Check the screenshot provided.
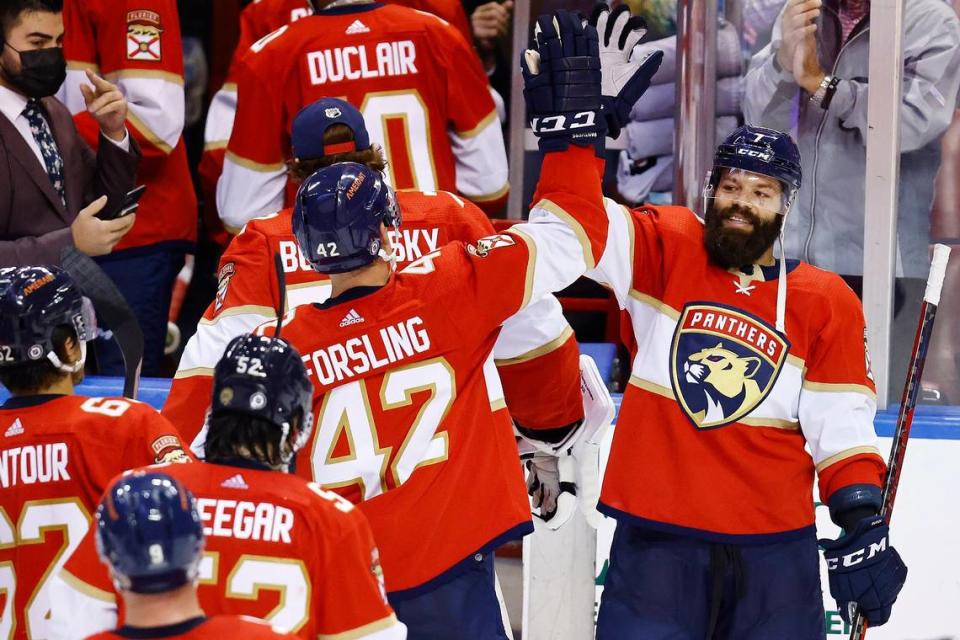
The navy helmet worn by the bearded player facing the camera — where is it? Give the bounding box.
[704,125,802,214]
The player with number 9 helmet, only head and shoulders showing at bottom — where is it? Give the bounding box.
[84,471,289,640]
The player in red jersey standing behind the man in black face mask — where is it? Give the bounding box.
[62,0,197,376]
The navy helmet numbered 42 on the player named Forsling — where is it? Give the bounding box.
[293,162,400,273]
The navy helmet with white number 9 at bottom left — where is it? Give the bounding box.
[95,471,203,593]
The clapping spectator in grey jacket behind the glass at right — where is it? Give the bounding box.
[744,0,960,278]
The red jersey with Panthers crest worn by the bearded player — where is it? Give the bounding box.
[568,195,885,542]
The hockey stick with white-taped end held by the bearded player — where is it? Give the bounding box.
[850,244,950,640]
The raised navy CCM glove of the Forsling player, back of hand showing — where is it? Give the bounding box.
[520,10,606,156]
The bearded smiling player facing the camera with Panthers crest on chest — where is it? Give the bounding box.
[556,5,906,640]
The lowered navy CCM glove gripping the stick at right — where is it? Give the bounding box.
[819,515,907,627]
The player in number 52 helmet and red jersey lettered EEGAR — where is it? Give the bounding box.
[54,334,406,640]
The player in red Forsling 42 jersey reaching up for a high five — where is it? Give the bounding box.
[249,19,659,640]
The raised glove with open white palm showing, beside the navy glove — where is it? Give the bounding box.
[590,2,663,138]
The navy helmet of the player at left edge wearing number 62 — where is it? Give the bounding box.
[0,267,96,372]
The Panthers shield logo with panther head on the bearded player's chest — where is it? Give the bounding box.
[670,302,790,429]
